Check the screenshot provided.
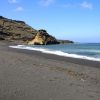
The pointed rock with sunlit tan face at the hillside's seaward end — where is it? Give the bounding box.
[28,30,59,45]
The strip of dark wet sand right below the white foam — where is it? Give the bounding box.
[8,43,100,68]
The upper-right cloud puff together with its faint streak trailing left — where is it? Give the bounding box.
[63,1,93,9]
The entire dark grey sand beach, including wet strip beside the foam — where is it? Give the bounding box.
[0,42,100,100]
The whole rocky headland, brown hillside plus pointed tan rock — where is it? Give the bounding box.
[0,16,73,45]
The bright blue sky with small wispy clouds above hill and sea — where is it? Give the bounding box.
[0,0,100,43]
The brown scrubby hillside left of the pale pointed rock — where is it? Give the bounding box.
[0,16,37,41]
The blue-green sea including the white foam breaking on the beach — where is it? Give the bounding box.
[10,43,100,61]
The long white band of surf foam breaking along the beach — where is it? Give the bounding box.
[9,45,100,61]
